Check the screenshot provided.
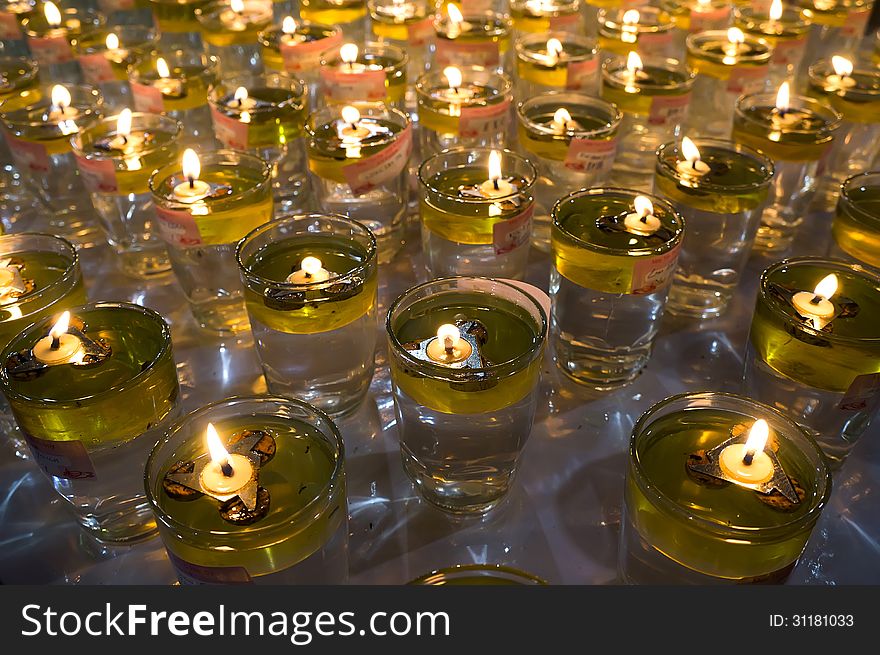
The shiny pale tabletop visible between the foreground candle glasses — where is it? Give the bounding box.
[0,208,880,584]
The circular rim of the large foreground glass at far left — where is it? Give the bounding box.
[0,300,177,406]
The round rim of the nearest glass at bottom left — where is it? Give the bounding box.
[144,395,345,538]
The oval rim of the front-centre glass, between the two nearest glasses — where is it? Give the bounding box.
[385,275,549,381]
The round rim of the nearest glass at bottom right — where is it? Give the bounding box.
[627,391,832,539]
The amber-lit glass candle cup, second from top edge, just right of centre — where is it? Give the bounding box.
[516,32,599,99]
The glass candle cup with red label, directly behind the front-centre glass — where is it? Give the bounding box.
[419,148,537,279]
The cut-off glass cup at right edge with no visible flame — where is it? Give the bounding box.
[831,171,880,269]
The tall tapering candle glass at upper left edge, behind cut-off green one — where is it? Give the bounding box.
[0,86,103,247]
